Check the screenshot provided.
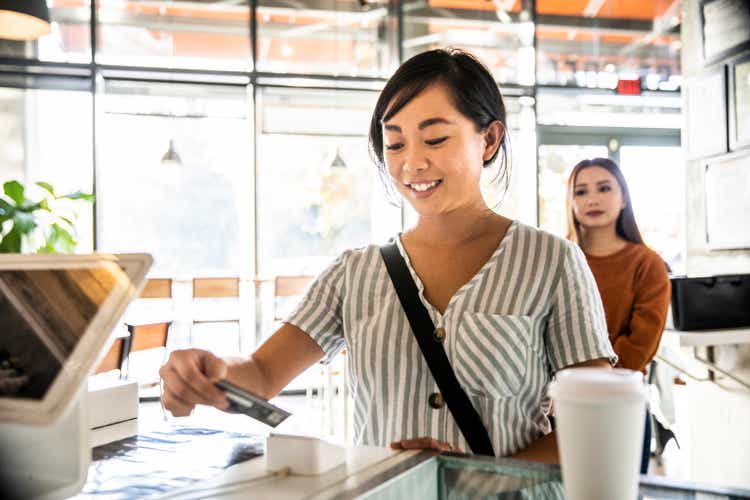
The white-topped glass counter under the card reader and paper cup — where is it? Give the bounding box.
[76,418,750,500]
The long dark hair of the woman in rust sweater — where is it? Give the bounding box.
[565,158,643,245]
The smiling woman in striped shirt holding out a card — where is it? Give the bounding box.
[161,50,615,462]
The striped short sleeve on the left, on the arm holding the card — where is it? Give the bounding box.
[284,253,347,364]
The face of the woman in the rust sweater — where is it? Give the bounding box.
[573,166,625,228]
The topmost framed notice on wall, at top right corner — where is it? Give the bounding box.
[701,0,750,63]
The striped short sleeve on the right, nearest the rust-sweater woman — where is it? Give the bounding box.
[545,241,617,373]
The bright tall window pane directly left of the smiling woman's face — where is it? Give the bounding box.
[258,89,400,276]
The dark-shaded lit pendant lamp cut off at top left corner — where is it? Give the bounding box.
[0,0,51,41]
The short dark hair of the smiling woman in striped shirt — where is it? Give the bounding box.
[370,48,510,203]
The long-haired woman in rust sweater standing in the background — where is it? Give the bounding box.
[567,158,670,473]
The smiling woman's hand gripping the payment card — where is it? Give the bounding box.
[159,349,234,417]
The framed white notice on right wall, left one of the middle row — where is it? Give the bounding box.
[685,66,727,158]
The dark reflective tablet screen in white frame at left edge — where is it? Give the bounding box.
[0,265,119,400]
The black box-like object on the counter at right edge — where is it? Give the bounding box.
[670,274,750,330]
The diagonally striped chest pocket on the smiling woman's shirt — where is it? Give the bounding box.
[454,312,538,399]
